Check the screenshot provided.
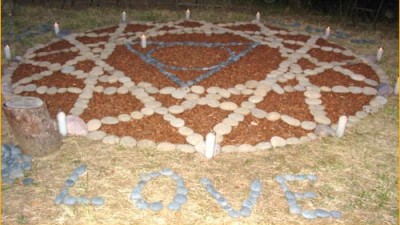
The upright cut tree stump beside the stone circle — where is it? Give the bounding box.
[3,96,62,156]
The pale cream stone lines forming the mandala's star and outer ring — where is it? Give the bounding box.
[2,20,388,154]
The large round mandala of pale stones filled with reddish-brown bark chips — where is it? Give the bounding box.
[3,21,387,153]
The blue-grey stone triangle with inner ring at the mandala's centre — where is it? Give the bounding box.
[125,41,259,87]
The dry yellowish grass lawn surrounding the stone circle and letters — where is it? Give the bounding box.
[2,3,399,224]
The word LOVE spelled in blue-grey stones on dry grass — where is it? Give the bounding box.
[55,165,342,219]
